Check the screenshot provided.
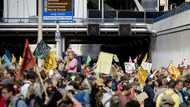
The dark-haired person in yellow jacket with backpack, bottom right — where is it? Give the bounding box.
[156,81,180,107]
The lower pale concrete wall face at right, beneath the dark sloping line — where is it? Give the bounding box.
[151,30,190,68]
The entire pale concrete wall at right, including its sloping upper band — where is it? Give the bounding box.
[151,10,190,68]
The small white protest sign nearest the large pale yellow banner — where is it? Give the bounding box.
[124,62,135,73]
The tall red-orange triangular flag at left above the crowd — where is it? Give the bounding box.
[21,39,36,72]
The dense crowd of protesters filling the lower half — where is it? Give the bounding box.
[0,50,190,107]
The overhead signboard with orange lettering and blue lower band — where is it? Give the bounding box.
[43,0,73,21]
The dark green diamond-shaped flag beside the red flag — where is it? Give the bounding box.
[34,40,50,59]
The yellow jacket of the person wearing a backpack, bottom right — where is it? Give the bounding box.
[156,89,180,107]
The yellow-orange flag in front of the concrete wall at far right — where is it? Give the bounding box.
[168,64,180,80]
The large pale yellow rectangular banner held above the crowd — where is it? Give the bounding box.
[95,52,113,74]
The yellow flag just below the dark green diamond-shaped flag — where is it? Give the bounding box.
[44,51,57,72]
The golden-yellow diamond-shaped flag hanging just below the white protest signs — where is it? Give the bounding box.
[137,67,148,87]
